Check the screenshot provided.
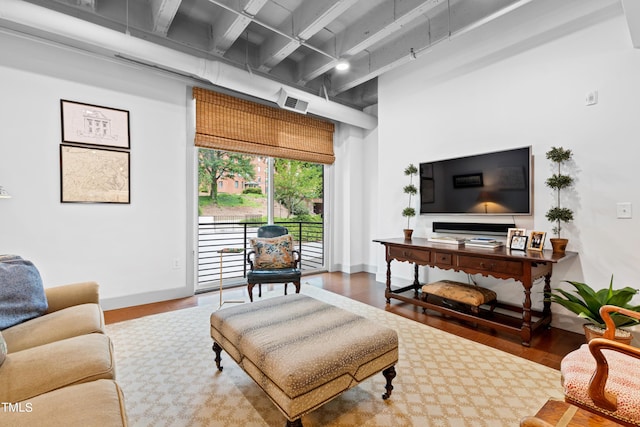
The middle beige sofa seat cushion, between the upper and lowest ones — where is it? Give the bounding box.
[0,334,115,402]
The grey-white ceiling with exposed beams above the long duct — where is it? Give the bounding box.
[13,0,531,109]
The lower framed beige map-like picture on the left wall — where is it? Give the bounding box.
[60,144,131,204]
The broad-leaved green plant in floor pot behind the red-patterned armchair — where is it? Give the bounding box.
[548,276,640,344]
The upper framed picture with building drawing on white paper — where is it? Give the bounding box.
[60,99,131,149]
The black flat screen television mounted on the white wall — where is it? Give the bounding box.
[420,147,532,215]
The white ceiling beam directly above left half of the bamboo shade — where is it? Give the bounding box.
[211,0,267,55]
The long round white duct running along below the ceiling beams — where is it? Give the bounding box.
[0,0,378,129]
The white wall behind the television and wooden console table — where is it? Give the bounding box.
[372,0,640,330]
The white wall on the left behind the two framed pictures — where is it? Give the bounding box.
[0,33,193,308]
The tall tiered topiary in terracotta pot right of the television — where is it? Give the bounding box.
[546,147,573,253]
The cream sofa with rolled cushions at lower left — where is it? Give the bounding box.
[0,282,127,426]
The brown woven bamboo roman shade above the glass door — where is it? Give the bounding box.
[193,87,335,164]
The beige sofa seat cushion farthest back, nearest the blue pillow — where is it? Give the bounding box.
[3,304,104,353]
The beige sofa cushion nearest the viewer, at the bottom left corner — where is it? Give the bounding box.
[2,380,127,427]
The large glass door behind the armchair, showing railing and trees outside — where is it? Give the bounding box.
[198,148,324,289]
